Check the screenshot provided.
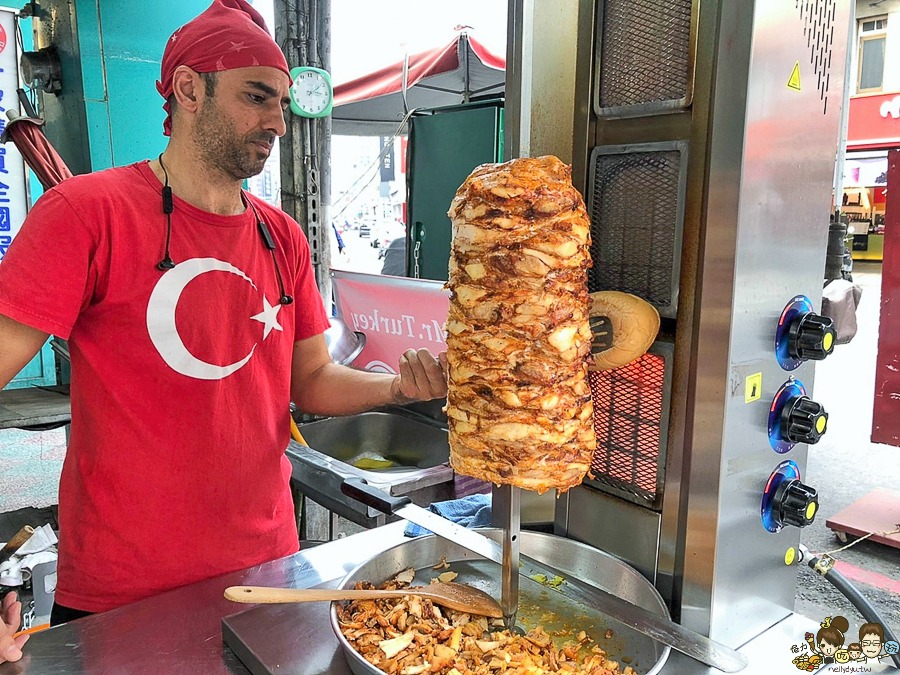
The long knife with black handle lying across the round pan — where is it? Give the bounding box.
[341,478,748,673]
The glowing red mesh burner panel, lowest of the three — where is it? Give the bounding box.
[588,354,666,505]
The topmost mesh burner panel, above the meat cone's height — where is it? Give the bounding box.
[599,0,691,108]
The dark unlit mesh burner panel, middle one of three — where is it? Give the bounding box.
[588,150,681,310]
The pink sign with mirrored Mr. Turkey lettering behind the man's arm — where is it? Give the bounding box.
[331,270,450,373]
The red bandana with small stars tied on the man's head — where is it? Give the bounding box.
[156,0,291,136]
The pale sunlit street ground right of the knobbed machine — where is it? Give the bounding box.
[796,263,900,633]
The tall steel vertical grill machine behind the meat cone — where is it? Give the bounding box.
[556,0,850,647]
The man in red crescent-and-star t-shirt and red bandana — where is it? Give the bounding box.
[0,0,446,662]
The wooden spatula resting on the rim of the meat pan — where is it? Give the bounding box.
[225,583,503,619]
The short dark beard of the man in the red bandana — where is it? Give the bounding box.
[194,100,275,180]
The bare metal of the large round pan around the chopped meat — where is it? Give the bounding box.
[331,529,669,675]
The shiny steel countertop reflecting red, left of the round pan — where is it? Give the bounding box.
[0,521,406,675]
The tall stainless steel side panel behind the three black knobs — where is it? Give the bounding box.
[681,0,848,646]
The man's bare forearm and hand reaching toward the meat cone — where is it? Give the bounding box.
[291,335,447,415]
